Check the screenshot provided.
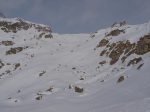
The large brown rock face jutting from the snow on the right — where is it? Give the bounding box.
[97,24,150,66]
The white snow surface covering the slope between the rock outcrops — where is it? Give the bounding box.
[0,19,150,112]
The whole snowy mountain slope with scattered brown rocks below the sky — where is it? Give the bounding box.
[0,18,150,112]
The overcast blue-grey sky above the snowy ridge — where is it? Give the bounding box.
[0,0,150,33]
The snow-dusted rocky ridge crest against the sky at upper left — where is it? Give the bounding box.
[0,18,53,39]
